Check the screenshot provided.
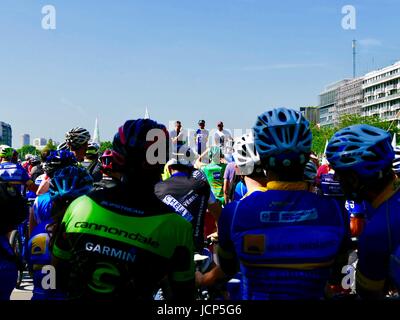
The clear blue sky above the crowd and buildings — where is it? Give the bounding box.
[0,0,400,147]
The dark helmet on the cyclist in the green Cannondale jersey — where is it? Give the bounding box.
[113,119,170,170]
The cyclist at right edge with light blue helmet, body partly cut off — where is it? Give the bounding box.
[326,124,400,298]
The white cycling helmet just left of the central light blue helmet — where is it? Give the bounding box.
[232,133,265,176]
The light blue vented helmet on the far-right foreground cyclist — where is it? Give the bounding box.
[326,124,394,178]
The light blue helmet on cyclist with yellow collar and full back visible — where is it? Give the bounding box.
[253,108,312,168]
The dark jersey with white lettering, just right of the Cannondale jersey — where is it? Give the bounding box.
[154,170,211,252]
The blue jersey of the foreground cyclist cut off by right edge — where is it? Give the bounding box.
[357,182,400,290]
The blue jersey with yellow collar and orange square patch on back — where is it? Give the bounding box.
[218,182,345,300]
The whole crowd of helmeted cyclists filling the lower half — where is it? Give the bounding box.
[0,108,400,301]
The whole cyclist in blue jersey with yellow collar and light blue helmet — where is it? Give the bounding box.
[218,108,345,300]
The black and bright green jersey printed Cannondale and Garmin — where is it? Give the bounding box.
[53,185,194,300]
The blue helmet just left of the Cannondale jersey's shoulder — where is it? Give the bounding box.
[49,166,93,200]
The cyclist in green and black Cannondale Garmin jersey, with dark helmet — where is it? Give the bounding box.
[52,119,194,300]
